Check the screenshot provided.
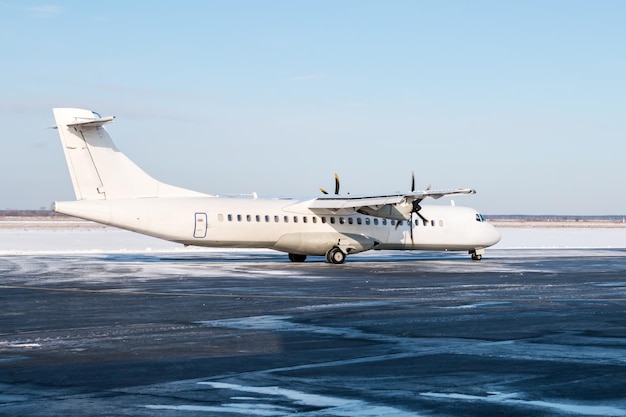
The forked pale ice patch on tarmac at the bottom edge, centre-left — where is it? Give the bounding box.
[145,382,418,417]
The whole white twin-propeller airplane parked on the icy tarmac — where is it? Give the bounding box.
[52,108,500,264]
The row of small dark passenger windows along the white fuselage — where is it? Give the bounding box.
[217,214,443,227]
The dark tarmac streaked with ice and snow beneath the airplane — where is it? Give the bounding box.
[0,249,626,417]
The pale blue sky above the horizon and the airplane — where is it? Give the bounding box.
[0,0,626,214]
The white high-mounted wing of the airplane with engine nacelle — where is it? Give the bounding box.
[308,188,476,220]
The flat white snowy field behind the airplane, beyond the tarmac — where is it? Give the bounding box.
[0,220,626,256]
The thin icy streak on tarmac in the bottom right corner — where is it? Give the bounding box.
[420,392,626,417]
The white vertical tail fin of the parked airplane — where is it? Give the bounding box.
[53,108,206,200]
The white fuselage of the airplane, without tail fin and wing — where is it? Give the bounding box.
[54,197,500,255]
